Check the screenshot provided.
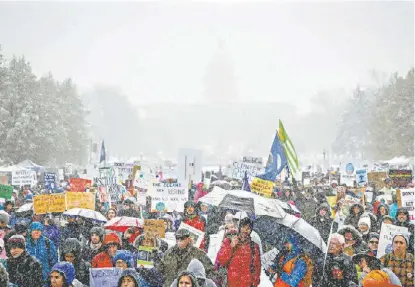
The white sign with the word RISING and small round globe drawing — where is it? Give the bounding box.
[149,182,189,212]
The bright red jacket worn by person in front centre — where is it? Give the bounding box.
[216,238,261,287]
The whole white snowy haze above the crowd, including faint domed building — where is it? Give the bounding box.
[0,1,414,166]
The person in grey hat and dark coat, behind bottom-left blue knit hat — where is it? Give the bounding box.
[61,238,91,285]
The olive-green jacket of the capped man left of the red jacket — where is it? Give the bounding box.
[156,245,214,287]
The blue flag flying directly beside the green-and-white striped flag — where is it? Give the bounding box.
[256,133,287,182]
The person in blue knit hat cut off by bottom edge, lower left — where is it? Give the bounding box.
[45,262,84,287]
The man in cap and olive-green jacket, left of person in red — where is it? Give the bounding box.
[155,229,214,287]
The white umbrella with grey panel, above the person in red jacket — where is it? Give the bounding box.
[199,186,285,218]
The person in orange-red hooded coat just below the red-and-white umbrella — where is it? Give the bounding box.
[92,233,121,268]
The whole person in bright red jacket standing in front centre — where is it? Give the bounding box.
[216,218,261,287]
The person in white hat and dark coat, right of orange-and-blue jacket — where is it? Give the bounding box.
[322,233,358,287]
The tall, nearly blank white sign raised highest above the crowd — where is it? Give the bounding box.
[177,148,202,183]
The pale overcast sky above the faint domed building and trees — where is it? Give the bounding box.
[0,1,414,113]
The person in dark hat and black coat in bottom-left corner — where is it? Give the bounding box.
[7,235,44,287]
